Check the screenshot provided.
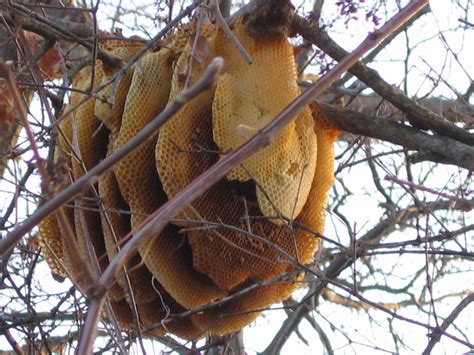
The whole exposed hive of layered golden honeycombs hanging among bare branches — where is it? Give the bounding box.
[39,19,338,340]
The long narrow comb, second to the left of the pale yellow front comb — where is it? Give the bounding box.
[114,48,172,228]
